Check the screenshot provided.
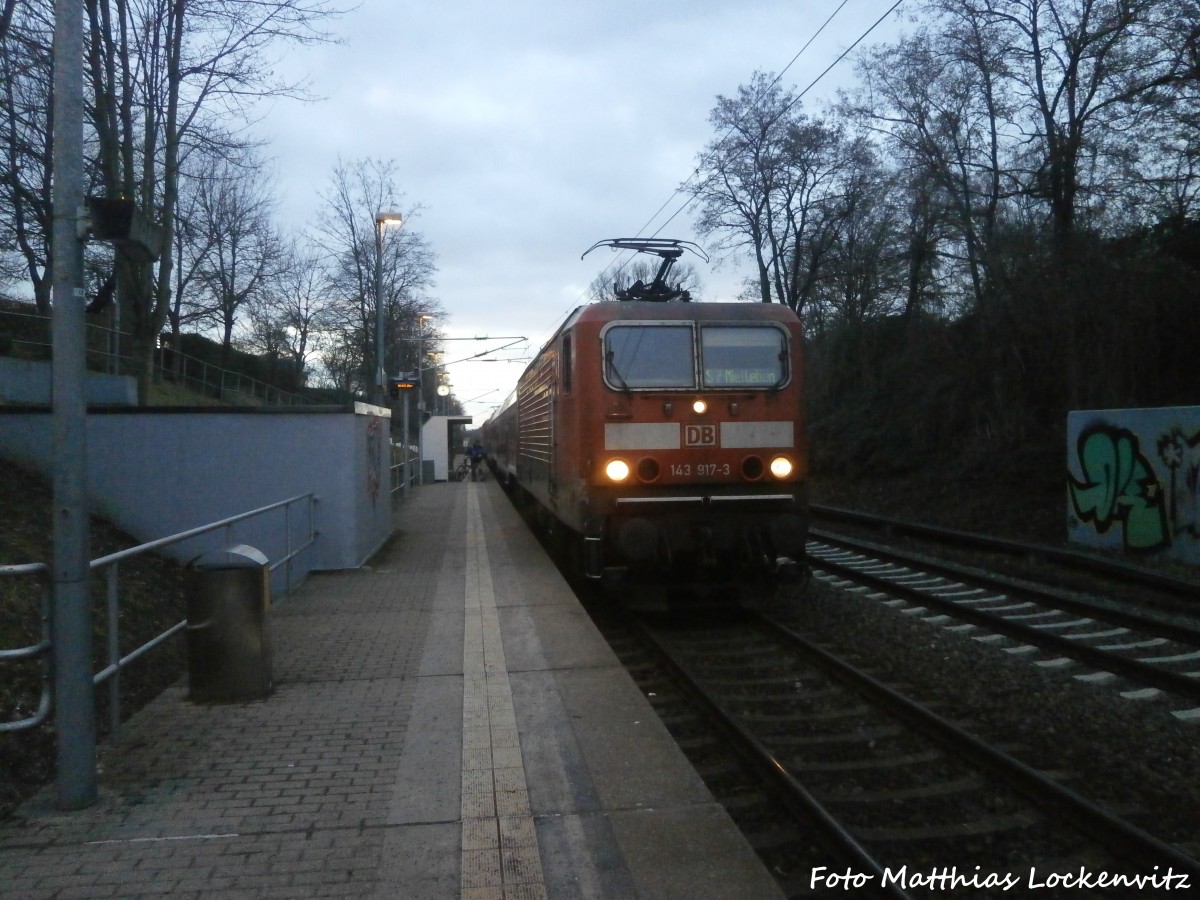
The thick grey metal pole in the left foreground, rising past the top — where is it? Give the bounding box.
[50,0,96,810]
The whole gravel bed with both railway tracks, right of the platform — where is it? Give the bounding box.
[552,501,1200,898]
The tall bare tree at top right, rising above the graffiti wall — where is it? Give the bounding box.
[932,0,1190,247]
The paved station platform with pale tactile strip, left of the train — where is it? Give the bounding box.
[0,481,782,900]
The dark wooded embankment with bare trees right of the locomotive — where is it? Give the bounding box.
[686,0,1200,472]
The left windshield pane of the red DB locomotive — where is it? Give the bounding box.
[604,325,696,390]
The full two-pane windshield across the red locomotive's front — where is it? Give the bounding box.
[604,323,788,390]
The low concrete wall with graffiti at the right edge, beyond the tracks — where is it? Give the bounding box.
[1067,408,1200,562]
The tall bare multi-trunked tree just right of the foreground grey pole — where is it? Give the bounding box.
[85,0,348,400]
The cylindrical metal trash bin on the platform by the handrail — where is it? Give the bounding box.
[186,544,272,703]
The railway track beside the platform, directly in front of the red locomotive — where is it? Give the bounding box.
[628,616,1200,898]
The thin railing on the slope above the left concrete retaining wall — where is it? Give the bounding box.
[0,310,328,406]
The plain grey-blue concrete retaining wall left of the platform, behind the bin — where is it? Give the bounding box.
[0,403,391,588]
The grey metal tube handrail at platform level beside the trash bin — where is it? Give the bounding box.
[0,493,319,740]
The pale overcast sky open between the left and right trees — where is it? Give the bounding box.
[258,0,904,424]
